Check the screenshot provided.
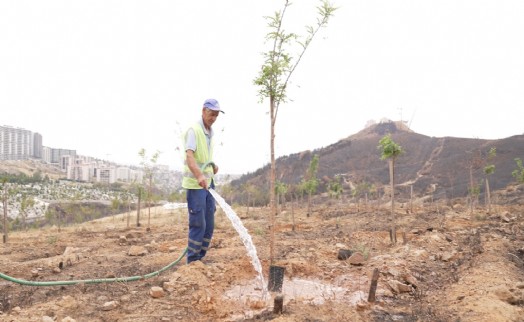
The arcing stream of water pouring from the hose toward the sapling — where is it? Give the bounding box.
[209,189,268,298]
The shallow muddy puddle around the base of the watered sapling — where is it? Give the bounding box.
[224,278,367,305]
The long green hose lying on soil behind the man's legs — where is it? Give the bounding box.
[0,248,187,286]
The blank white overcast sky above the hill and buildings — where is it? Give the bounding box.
[0,0,524,173]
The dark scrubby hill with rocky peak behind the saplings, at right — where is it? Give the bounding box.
[232,122,524,203]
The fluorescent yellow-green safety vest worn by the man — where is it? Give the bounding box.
[182,123,214,189]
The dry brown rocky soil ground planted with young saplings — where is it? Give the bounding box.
[0,203,524,321]
